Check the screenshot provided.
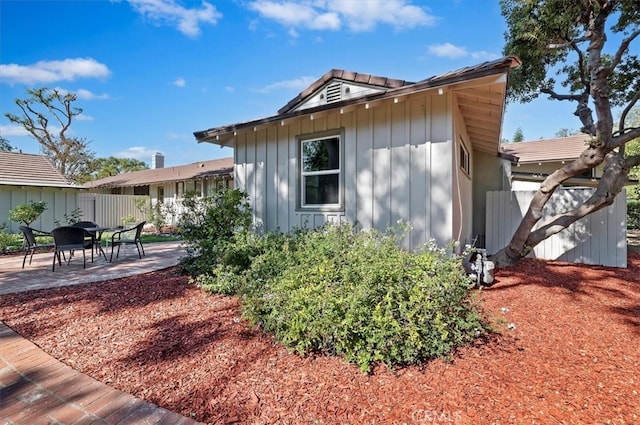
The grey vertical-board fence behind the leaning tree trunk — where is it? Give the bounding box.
[486,188,627,267]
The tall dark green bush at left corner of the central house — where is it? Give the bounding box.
[179,189,251,275]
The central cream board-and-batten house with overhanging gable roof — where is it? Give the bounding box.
[194,57,520,249]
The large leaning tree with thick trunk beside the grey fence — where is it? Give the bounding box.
[492,0,640,267]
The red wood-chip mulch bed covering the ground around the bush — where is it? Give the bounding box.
[0,253,640,424]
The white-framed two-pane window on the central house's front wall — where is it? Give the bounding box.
[300,135,341,208]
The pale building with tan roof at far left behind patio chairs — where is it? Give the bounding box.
[0,152,81,233]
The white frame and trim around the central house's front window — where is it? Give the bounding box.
[296,129,344,212]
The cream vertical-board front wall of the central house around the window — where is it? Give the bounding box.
[234,94,454,249]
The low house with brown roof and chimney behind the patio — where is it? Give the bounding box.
[84,154,233,224]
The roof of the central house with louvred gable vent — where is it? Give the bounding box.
[193,56,521,153]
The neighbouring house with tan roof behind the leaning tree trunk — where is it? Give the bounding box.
[500,134,604,190]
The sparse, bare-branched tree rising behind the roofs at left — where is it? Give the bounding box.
[5,88,94,182]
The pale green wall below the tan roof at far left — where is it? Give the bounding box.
[0,186,79,233]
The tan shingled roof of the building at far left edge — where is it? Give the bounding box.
[0,152,79,188]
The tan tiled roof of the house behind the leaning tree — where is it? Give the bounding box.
[500,134,591,164]
